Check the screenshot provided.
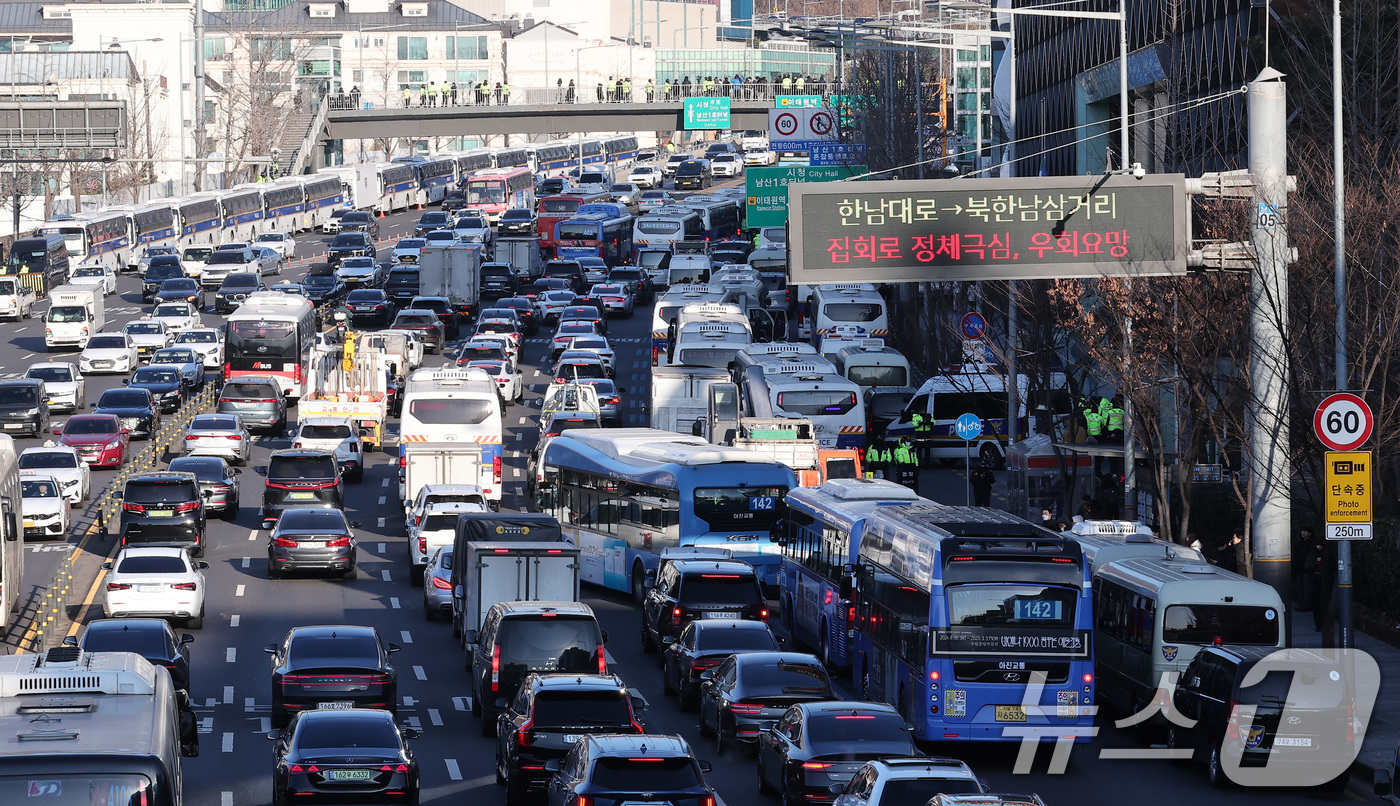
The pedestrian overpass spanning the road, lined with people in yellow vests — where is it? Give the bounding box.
[316,99,773,140]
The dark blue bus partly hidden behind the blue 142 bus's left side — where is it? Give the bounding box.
[778,479,931,670]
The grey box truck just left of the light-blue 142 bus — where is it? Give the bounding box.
[452,540,581,652]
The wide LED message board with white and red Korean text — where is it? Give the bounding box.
[788,174,1187,283]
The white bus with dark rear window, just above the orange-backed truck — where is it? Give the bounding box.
[735,357,865,448]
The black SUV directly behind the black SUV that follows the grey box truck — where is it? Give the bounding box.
[496,674,645,806]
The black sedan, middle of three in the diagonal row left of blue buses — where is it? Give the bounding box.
[700,652,828,756]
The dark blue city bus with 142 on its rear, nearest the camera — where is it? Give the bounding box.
[851,505,1095,743]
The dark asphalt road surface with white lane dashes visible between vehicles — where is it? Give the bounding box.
[0,202,1362,806]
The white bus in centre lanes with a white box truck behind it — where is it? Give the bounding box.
[399,368,504,509]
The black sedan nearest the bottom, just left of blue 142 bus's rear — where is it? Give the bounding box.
[759,702,923,803]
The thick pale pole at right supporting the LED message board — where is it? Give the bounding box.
[1247,67,1288,635]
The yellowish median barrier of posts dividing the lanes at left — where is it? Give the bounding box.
[17,381,218,653]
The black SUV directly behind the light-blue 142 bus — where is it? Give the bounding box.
[641,560,769,652]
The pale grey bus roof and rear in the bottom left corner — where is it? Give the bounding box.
[0,646,199,806]
